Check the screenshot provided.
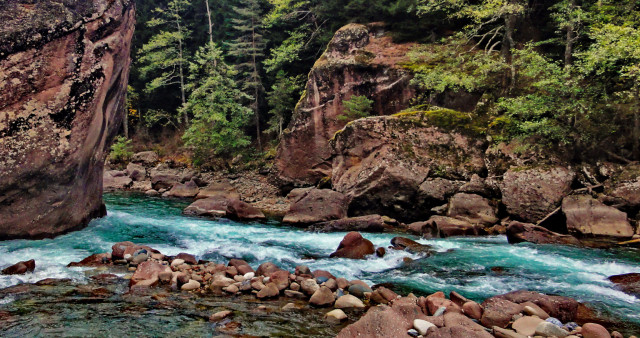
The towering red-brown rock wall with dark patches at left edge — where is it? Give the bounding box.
[0,0,135,239]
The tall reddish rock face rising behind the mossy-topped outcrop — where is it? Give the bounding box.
[276,24,414,186]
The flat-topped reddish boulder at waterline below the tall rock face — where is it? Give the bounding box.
[283,189,349,225]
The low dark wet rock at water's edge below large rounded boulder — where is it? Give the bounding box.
[507,221,581,246]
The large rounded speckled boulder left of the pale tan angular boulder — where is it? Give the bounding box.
[500,166,575,223]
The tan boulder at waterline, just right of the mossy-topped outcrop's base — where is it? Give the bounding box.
[447,193,498,225]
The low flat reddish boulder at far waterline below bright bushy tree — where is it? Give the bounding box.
[184,196,266,221]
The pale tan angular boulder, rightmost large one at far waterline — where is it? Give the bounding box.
[562,195,634,239]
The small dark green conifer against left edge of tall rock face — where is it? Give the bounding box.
[267,70,304,136]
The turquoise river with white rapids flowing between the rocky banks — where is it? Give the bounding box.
[0,194,640,327]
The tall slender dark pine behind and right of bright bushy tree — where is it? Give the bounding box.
[229,0,266,150]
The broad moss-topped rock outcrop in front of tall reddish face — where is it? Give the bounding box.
[331,111,484,220]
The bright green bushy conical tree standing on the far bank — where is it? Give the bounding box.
[181,43,252,164]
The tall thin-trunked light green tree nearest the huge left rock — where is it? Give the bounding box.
[139,0,191,124]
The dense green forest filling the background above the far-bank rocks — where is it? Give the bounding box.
[120,0,640,166]
